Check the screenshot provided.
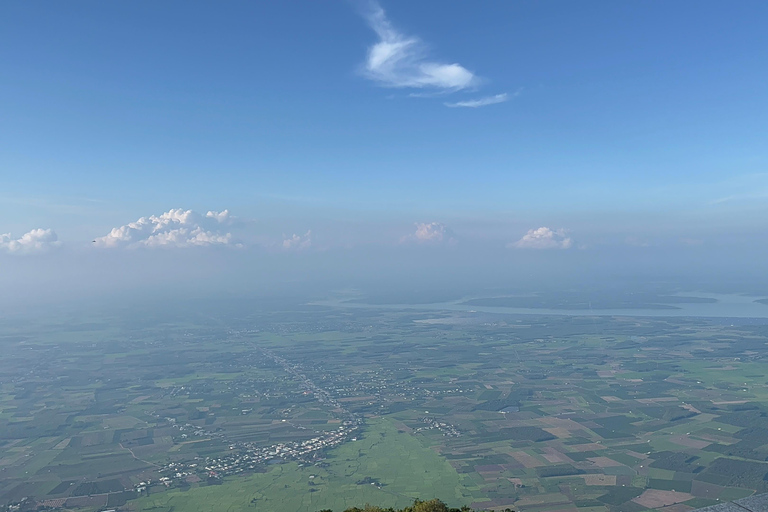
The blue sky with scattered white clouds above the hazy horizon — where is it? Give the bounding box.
[0,0,768,302]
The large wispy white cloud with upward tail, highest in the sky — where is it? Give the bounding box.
[363,2,478,91]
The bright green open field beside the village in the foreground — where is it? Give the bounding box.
[130,419,480,512]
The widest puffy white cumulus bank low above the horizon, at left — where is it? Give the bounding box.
[94,208,239,248]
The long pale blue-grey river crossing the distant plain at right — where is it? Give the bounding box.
[314,293,768,318]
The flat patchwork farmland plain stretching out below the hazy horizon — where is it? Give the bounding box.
[0,303,768,512]
